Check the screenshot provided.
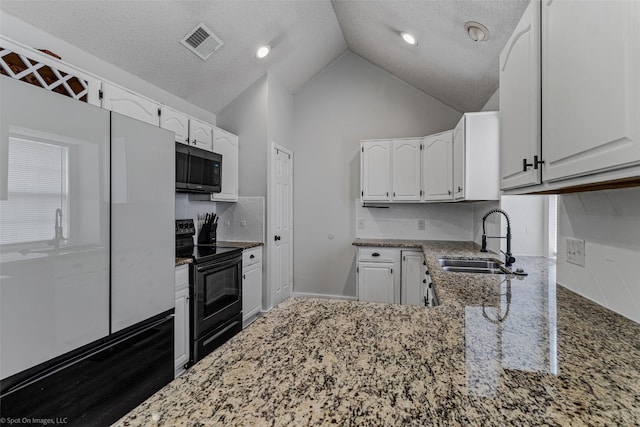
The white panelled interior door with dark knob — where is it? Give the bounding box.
[269,144,293,307]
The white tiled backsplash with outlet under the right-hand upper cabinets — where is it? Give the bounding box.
[557,188,640,322]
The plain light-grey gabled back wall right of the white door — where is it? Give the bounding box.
[293,52,461,296]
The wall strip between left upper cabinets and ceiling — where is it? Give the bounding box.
[0,12,216,125]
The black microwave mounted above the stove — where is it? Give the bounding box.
[176,142,222,193]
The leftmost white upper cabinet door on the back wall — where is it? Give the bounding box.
[361,141,391,202]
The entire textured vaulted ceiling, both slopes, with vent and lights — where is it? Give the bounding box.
[0,0,528,113]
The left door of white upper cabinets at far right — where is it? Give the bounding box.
[500,0,542,190]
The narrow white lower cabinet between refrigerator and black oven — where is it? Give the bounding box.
[173,265,189,377]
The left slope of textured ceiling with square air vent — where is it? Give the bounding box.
[0,0,347,114]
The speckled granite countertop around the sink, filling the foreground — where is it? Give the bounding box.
[116,240,640,426]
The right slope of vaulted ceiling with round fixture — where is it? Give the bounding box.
[333,0,529,112]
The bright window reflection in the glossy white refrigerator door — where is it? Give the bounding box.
[0,137,69,245]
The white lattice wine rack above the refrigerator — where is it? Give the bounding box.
[0,47,89,102]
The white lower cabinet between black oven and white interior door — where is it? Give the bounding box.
[242,247,262,327]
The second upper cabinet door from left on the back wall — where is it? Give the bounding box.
[391,138,421,201]
